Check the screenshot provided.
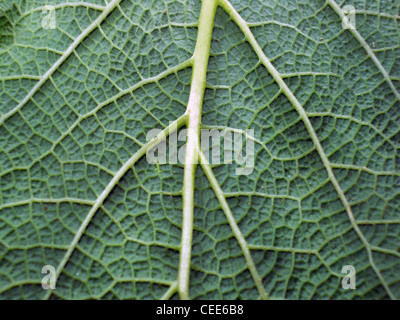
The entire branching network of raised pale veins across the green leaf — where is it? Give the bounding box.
[0,0,400,299]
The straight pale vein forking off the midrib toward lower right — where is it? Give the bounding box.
[199,152,269,300]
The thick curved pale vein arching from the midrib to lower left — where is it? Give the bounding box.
[44,115,187,299]
